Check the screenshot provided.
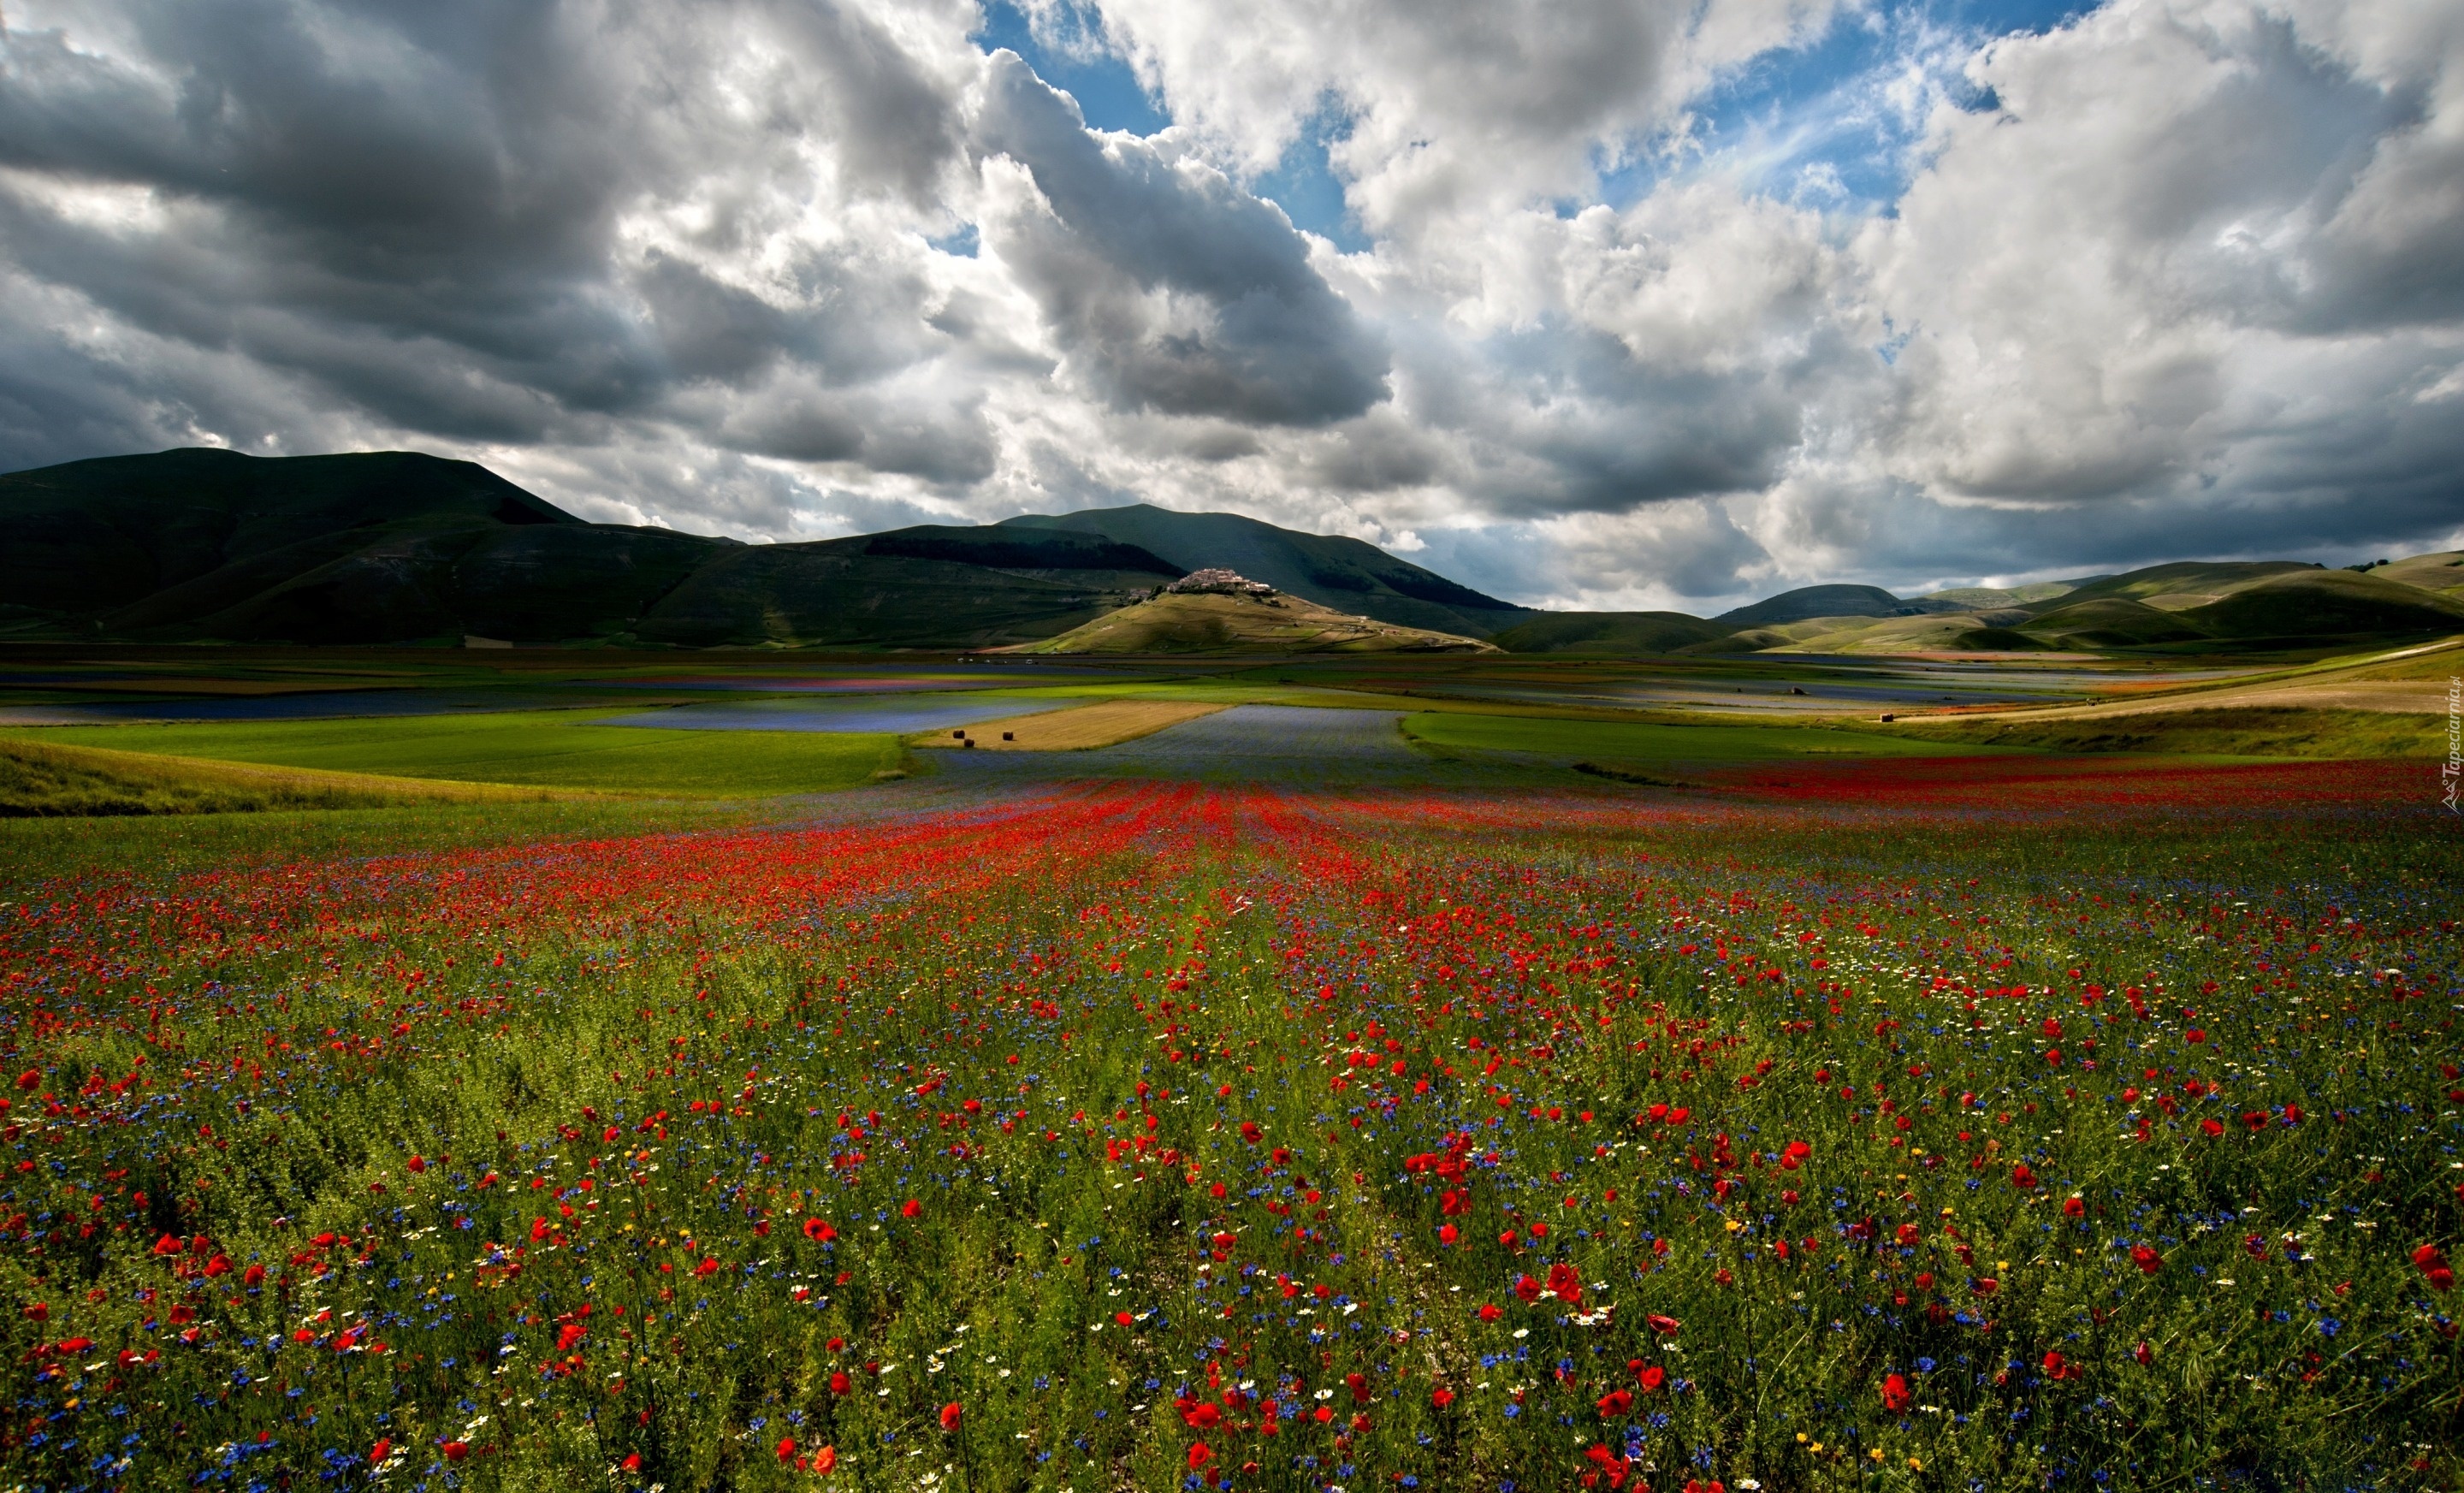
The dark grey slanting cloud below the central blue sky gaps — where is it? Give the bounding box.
[978,51,1387,426]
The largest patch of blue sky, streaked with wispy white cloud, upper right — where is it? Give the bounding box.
[1596,0,2094,216]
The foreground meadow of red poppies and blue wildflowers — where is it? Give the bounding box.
[0,759,2464,1493]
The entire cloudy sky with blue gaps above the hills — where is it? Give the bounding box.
[0,0,2464,613]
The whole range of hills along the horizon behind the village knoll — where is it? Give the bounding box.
[0,448,2464,655]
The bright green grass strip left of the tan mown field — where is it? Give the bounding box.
[21,709,899,796]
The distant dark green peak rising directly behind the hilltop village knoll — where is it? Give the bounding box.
[993,502,1543,638]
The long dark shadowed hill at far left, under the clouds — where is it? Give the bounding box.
[0,451,1182,648]
